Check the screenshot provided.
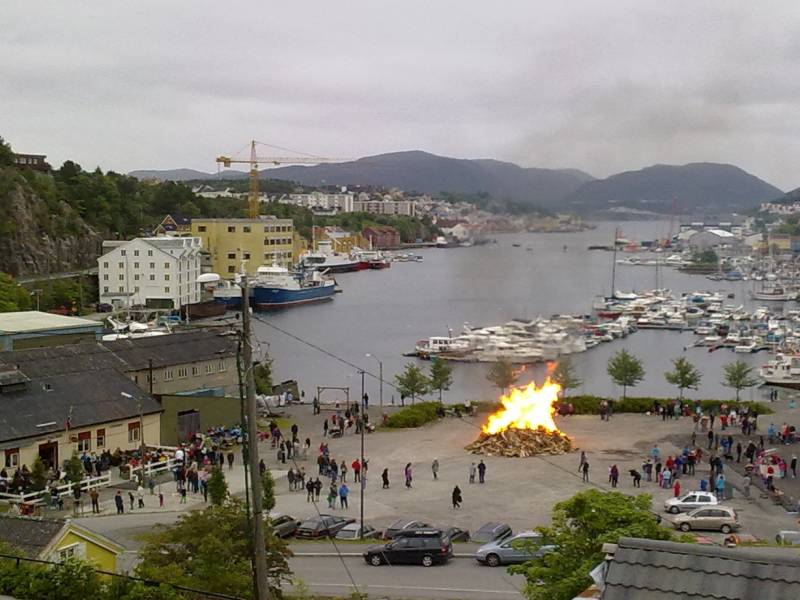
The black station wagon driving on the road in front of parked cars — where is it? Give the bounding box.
[363,529,453,567]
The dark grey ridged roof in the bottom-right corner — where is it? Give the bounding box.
[602,538,800,600]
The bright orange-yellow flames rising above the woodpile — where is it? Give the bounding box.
[483,377,561,434]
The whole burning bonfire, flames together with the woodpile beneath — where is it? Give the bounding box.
[466,378,572,457]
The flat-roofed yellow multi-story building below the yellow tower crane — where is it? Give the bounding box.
[192,216,297,278]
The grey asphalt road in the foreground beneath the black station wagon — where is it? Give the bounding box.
[290,545,525,600]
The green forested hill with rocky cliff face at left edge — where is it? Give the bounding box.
[0,138,245,276]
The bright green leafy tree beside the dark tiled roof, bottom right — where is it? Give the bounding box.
[508,490,672,600]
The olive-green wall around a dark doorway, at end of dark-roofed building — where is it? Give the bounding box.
[161,395,241,446]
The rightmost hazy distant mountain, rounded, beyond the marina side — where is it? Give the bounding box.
[565,163,783,213]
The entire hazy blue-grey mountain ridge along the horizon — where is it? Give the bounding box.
[130,150,783,214]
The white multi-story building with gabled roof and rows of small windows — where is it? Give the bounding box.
[97,237,202,309]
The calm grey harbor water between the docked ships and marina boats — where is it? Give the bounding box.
[254,221,780,404]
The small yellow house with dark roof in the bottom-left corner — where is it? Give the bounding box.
[0,515,124,573]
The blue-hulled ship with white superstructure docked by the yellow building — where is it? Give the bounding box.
[251,265,336,310]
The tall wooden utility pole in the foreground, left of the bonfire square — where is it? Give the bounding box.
[240,274,272,600]
